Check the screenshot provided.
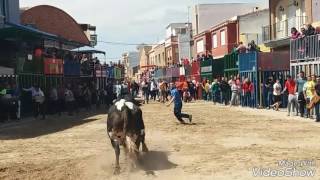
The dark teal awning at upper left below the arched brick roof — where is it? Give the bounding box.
[0,22,58,40]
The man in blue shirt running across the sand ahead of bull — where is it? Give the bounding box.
[167,84,192,124]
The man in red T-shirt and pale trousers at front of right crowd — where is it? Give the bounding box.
[281,76,298,116]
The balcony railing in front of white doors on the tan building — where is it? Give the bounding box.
[262,16,308,42]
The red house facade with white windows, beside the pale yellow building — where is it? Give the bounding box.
[210,17,239,58]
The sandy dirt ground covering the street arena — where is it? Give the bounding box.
[0,102,320,180]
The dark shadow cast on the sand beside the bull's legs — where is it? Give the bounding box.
[138,151,178,174]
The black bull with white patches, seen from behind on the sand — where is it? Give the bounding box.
[107,99,148,174]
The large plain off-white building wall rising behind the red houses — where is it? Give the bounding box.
[192,2,267,35]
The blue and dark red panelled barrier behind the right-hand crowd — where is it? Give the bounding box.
[239,52,290,107]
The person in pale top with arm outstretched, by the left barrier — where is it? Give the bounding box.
[23,85,45,119]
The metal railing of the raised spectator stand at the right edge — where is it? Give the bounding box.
[290,34,320,61]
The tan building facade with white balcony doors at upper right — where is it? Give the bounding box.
[262,0,313,51]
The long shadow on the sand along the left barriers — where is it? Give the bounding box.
[0,113,103,140]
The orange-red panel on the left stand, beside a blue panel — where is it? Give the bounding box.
[44,58,63,75]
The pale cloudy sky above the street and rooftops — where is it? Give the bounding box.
[20,0,267,61]
